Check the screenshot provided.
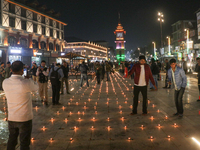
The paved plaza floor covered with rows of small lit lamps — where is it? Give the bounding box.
[0,73,200,150]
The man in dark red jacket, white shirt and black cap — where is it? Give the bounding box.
[129,55,157,115]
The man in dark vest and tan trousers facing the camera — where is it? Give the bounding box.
[36,60,49,105]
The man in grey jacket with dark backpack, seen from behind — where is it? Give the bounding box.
[49,63,64,105]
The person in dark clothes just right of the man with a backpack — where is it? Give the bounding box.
[61,61,70,94]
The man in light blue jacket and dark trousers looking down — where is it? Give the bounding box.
[168,59,187,118]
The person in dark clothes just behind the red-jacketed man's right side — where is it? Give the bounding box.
[150,58,160,89]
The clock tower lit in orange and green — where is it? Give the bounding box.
[114,17,126,63]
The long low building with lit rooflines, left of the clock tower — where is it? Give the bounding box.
[64,41,108,62]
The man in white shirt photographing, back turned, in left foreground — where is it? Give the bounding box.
[3,61,38,150]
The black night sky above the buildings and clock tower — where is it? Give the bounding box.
[39,0,200,50]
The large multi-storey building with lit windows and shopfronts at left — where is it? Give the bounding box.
[0,0,66,66]
